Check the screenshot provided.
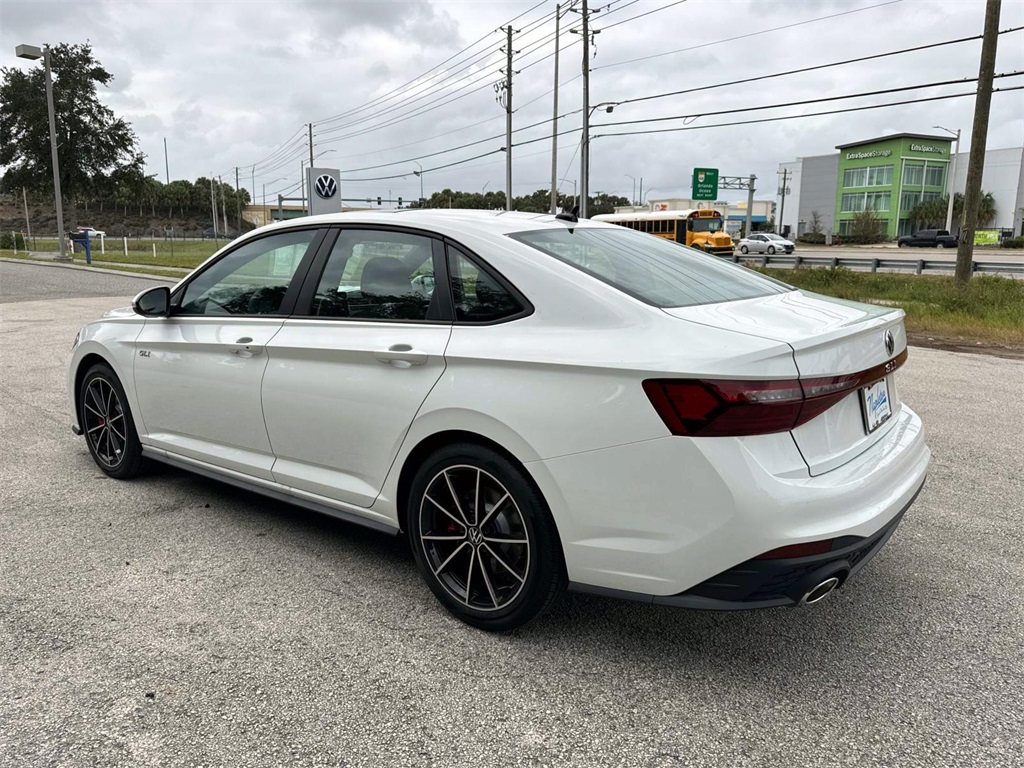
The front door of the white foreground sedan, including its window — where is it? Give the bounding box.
[134,228,326,480]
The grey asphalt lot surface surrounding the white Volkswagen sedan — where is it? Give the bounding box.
[0,263,1024,768]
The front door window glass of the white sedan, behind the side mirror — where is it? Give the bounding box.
[175,229,317,314]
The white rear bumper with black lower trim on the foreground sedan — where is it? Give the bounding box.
[527,406,931,609]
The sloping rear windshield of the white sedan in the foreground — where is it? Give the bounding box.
[510,226,793,308]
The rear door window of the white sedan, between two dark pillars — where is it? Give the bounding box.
[312,229,441,321]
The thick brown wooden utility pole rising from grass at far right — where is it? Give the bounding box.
[955,0,1001,286]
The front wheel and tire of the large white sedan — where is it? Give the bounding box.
[78,362,145,480]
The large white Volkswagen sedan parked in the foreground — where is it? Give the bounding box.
[69,210,930,630]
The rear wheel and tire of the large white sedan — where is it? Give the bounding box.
[406,443,567,632]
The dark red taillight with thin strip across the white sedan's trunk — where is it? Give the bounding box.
[643,349,906,437]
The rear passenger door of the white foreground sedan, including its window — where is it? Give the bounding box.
[262,227,452,507]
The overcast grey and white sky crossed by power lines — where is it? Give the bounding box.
[0,0,1024,207]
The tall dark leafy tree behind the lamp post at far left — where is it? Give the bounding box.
[0,43,144,201]
